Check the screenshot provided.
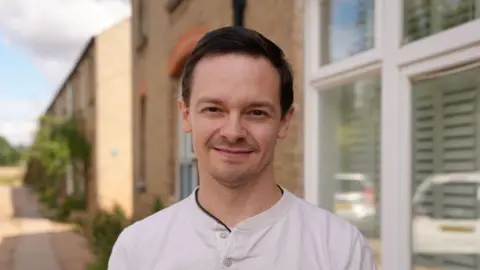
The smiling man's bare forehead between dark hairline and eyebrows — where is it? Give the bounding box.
[191,54,280,104]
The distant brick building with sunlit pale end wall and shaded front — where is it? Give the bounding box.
[35,19,133,215]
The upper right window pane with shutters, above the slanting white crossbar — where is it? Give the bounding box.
[404,0,480,43]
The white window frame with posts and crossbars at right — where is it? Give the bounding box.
[303,0,480,270]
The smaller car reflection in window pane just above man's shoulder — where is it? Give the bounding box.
[334,173,376,237]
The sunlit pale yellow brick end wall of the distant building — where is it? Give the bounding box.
[94,20,133,215]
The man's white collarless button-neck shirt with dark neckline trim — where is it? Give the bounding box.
[108,190,376,270]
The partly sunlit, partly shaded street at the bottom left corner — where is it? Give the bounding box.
[0,186,92,270]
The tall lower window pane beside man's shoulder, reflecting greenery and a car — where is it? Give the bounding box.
[320,77,381,264]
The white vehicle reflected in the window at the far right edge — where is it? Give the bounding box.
[412,172,480,255]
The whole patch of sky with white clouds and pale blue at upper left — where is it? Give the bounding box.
[0,0,131,145]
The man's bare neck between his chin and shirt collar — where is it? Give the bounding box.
[198,168,282,228]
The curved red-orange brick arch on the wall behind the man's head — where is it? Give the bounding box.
[168,26,209,77]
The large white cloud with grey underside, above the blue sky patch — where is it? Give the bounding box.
[0,0,131,85]
